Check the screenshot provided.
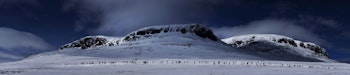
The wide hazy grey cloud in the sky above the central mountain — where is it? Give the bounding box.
[64,0,243,35]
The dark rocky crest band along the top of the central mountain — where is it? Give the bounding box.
[60,24,218,50]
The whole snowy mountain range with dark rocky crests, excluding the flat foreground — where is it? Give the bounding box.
[50,24,334,62]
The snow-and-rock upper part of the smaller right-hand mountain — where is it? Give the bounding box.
[223,34,329,61]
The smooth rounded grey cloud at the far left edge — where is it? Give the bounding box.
[0,27,53,51]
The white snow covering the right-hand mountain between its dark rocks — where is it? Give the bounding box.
[222,34,335,62]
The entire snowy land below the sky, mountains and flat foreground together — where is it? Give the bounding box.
[0,24,350,75]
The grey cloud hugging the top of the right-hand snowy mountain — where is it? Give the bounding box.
[212,19,328,45]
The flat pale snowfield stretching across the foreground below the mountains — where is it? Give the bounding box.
[0,55,350,75]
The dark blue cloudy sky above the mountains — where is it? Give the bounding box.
[0,0,350,59]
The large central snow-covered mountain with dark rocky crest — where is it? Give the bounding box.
[43,24,265,60]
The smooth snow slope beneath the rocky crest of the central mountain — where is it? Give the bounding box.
[40,32,263,59]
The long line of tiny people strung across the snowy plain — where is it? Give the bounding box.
[45,59,335,69]
